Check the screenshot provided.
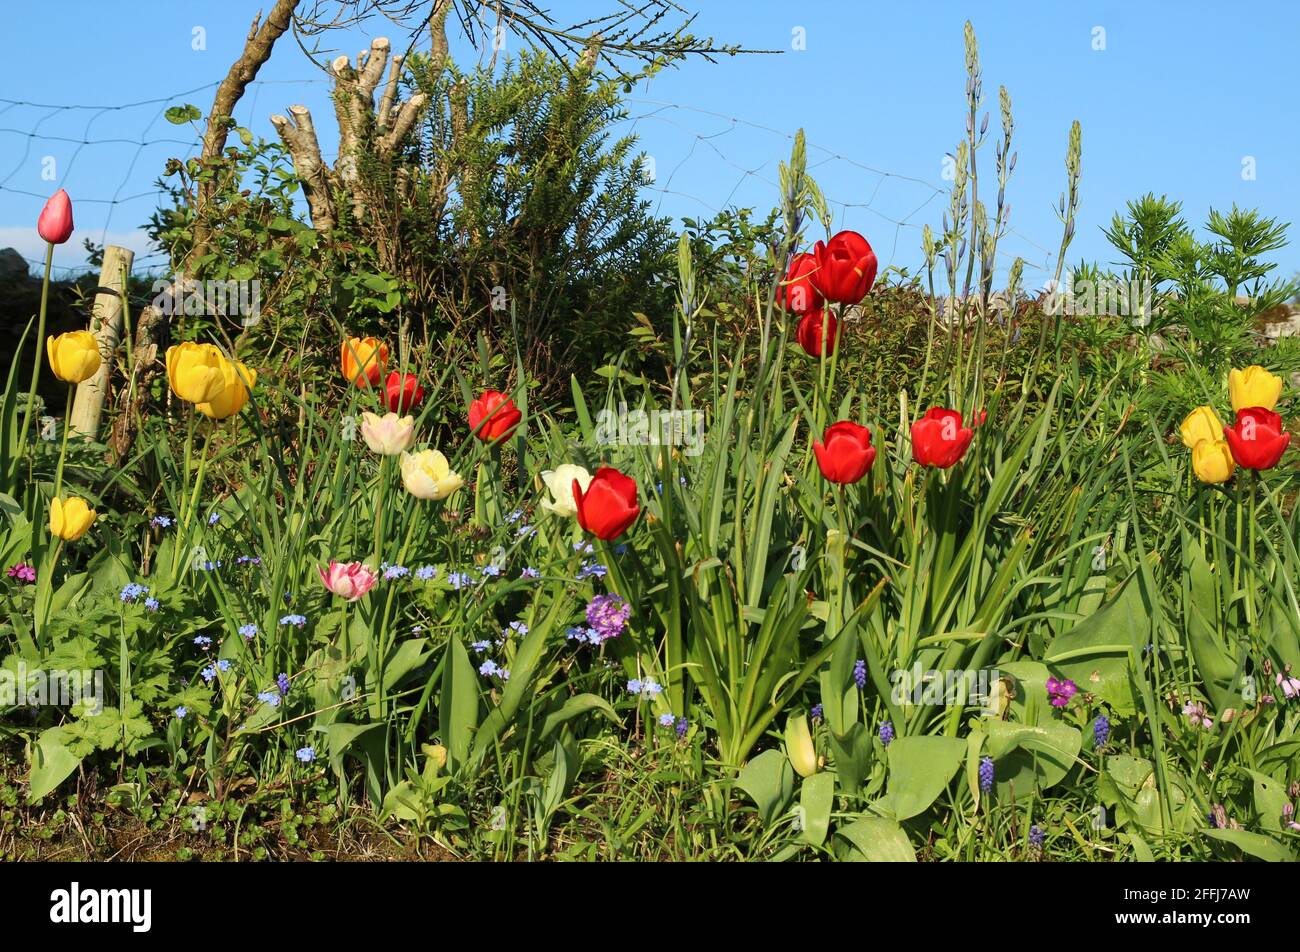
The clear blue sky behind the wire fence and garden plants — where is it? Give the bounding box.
[0,0,1300,286]
